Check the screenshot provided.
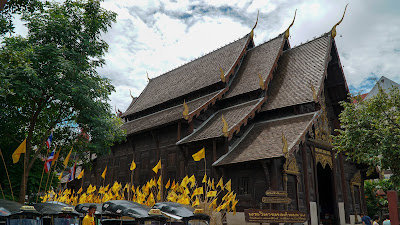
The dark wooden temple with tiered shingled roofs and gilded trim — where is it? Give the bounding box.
[84,9,366,224]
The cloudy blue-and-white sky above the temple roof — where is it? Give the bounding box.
[12,0,400,112]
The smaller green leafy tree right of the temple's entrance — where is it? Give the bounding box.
[334,87,400,185]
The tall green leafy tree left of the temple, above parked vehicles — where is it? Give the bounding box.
[0,0,125,202]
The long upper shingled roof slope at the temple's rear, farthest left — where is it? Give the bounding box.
[123,34,251,116]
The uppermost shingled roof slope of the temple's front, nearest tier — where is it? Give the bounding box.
[261,33,331,111]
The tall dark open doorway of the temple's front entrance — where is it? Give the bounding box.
[317,163,337,225]
